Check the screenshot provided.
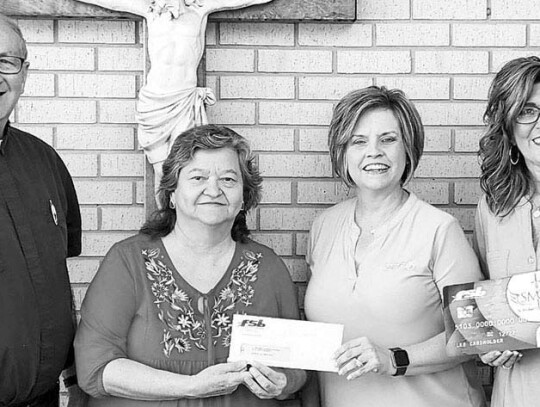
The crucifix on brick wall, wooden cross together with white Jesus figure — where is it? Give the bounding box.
[0,0,356,206]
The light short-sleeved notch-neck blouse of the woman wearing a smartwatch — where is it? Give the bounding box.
[305,193,485,407]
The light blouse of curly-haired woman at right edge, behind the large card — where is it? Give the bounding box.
[475,197,540,407]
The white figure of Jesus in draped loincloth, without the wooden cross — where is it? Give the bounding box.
[78,0,272,188]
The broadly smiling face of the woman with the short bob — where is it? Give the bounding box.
[345,109,407,198]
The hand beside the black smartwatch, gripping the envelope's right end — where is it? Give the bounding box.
[334,337,396,380]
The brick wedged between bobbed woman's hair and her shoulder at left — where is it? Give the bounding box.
[297,180,354,204]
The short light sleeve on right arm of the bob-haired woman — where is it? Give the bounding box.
[432,218,483,297]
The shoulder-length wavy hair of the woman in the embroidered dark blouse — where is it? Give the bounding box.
[140,125,262,242]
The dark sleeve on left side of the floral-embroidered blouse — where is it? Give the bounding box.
[75,245,137,397]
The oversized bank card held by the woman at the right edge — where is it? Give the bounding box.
[443,271,540,355]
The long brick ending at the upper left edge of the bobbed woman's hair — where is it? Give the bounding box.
[259,102,333,125]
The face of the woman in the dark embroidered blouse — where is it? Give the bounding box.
[171,148,244,231]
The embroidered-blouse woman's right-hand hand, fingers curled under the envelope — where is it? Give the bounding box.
[244,362,287,399]
